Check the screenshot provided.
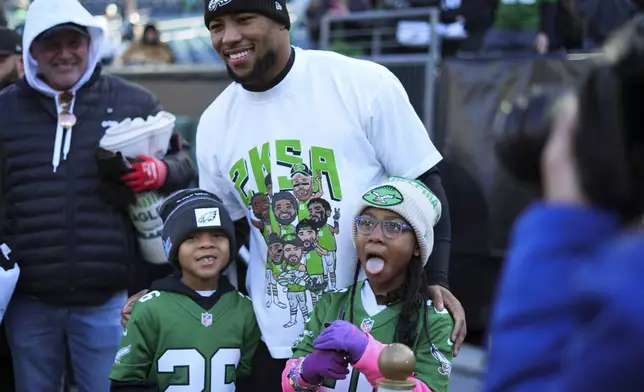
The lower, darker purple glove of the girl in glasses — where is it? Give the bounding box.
[300,350,349,385]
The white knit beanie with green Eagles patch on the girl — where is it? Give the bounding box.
[351,177,442,267]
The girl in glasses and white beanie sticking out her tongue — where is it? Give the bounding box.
[282,177,454,392]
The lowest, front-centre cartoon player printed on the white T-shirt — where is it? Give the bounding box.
[277,234,311,328]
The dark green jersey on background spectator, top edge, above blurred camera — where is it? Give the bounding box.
[493,0,557,32]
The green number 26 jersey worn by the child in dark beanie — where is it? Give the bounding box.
[110,291,260,392]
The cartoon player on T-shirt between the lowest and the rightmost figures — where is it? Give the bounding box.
[295,219,329,305]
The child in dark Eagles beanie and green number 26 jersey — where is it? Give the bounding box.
[110,189,260,392]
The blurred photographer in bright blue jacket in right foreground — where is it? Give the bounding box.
[485,16,644,392]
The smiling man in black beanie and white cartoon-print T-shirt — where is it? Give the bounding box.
[124,0,465,391]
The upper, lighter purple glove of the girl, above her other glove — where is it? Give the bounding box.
[313,320,369,364]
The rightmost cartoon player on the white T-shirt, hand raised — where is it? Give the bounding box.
[308,198,340,290]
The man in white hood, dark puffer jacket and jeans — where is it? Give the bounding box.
[0,0,194,392]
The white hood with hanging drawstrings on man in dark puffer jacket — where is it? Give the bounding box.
[22,0,105,172]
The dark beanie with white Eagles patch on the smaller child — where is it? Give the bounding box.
[159,188,237,268]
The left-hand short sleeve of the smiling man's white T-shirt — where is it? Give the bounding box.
[195,116,246,221]
